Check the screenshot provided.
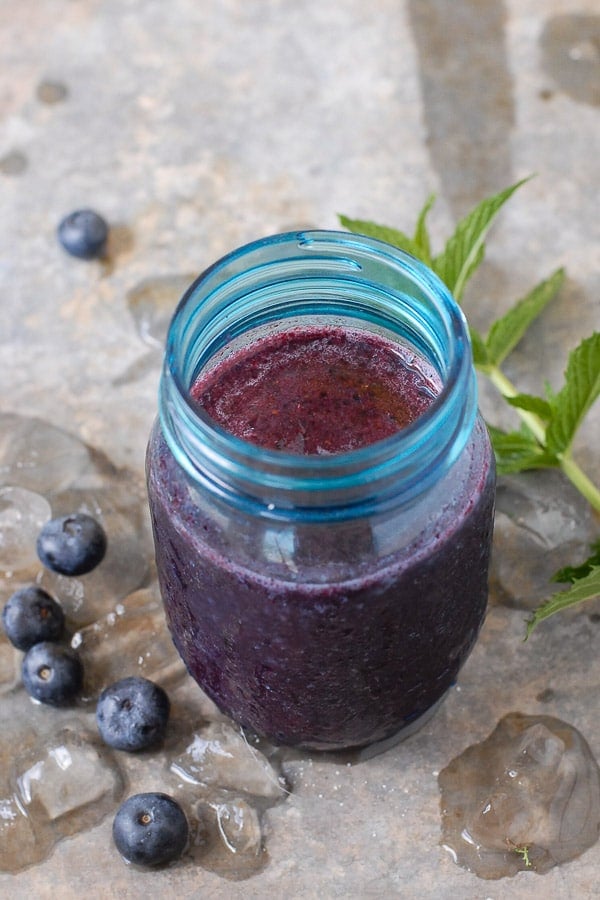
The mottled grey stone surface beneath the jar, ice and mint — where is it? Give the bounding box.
[0,0,600,900]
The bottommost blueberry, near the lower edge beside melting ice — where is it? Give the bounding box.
[113,793,189,866]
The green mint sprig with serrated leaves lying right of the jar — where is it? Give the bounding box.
[340,178,600,636]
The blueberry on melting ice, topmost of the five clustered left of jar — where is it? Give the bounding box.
[37,513,106,575]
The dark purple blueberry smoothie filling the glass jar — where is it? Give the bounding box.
[147,325,494,750]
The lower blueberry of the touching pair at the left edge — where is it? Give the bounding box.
[22,641,83,706]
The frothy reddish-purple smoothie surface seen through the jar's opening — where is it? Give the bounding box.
[191,328,439,454]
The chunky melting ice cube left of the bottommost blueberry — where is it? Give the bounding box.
[13,722,123,840]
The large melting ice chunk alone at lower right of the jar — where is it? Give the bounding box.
[439,713,600,878]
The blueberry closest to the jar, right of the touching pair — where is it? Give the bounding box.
[96,676,171,751]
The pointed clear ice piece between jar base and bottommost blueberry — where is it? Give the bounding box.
[170,722,285,799]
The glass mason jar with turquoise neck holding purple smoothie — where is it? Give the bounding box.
[147,231,494,750]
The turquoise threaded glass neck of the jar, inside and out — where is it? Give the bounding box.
[159,230,477,520]
